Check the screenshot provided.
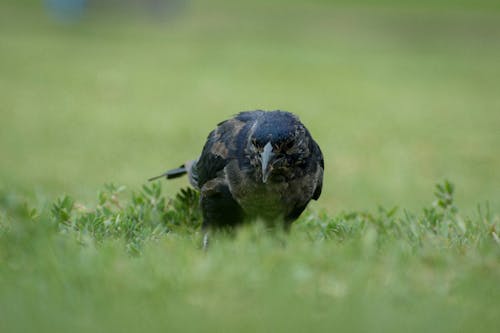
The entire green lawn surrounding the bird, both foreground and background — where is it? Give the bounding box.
[0,0,500,332]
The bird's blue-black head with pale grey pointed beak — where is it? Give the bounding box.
[248,111,310,183]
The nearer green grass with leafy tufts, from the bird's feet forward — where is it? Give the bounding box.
[0,183,500,332]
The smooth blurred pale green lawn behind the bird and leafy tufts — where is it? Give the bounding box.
[0,0,500,212]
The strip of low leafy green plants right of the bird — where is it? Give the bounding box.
[302,181,498,250]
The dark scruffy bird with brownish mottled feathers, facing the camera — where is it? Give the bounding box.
[150,110,324,237]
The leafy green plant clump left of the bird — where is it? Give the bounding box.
[51,183,201,253]
